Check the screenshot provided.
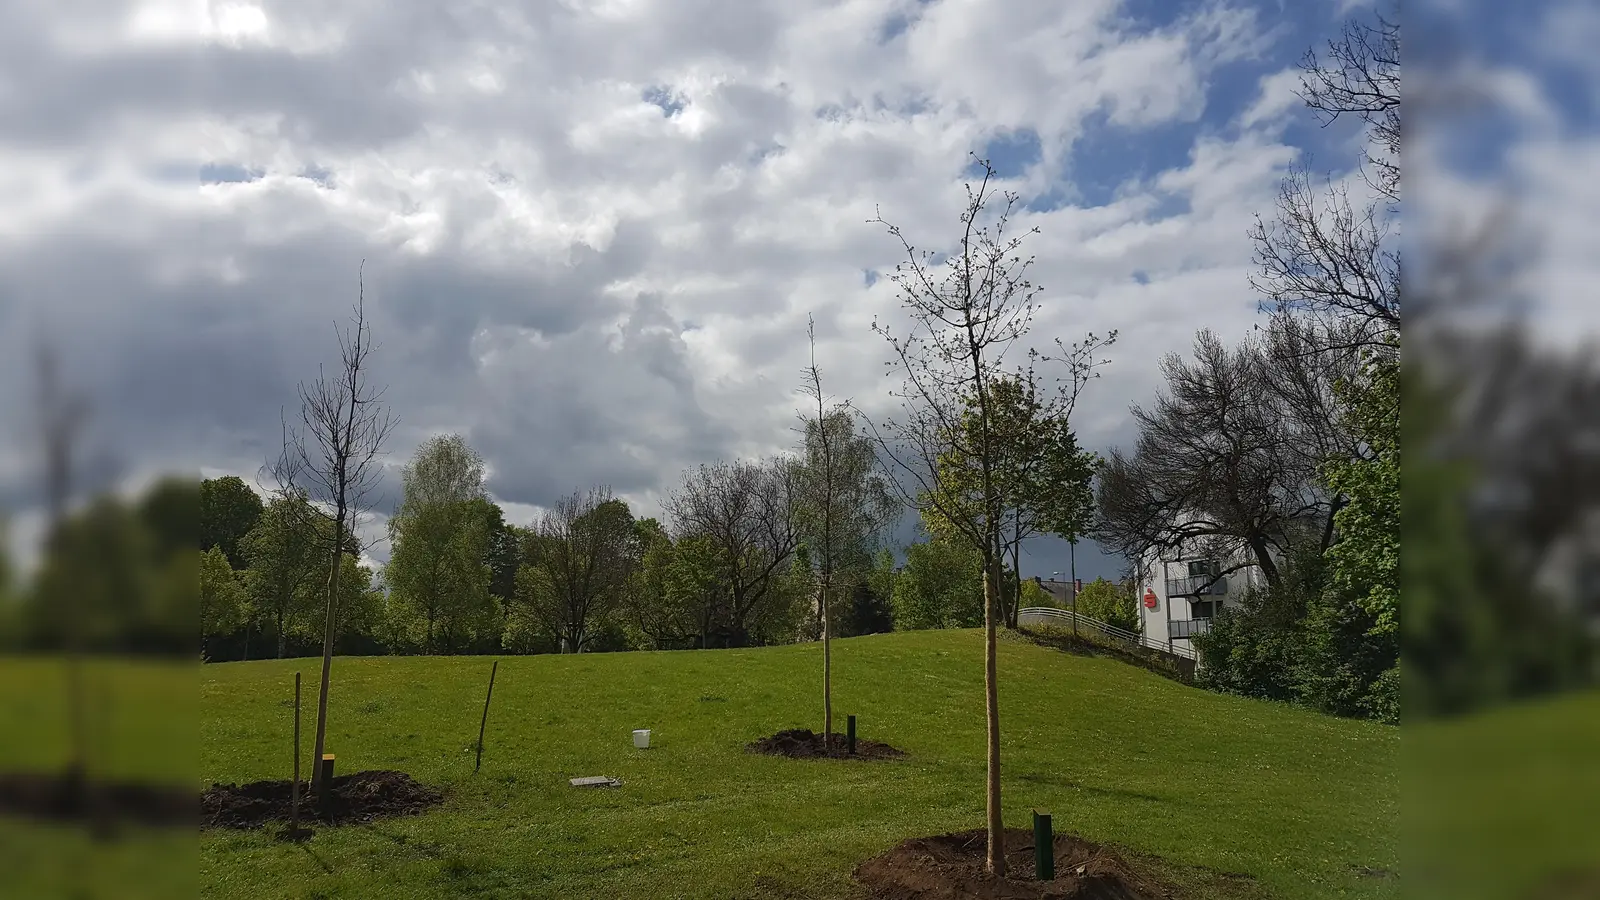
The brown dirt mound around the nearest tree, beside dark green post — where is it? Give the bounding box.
[854,828,1184,900]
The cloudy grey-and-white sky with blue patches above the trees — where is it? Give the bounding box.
[0,0,1600,577]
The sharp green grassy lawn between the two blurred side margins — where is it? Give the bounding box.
[200,631,1402,900]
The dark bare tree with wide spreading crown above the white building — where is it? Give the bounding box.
[1096,319,1358,585]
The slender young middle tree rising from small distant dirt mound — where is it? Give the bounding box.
[798,317,899,746]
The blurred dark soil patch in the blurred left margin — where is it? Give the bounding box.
[0,762,197,828]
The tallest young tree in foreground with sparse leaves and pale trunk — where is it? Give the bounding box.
[872,154,1040,874]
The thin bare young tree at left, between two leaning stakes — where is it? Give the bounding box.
[272,262,395,781]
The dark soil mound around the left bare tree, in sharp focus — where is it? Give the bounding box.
[200,762,445,828]
